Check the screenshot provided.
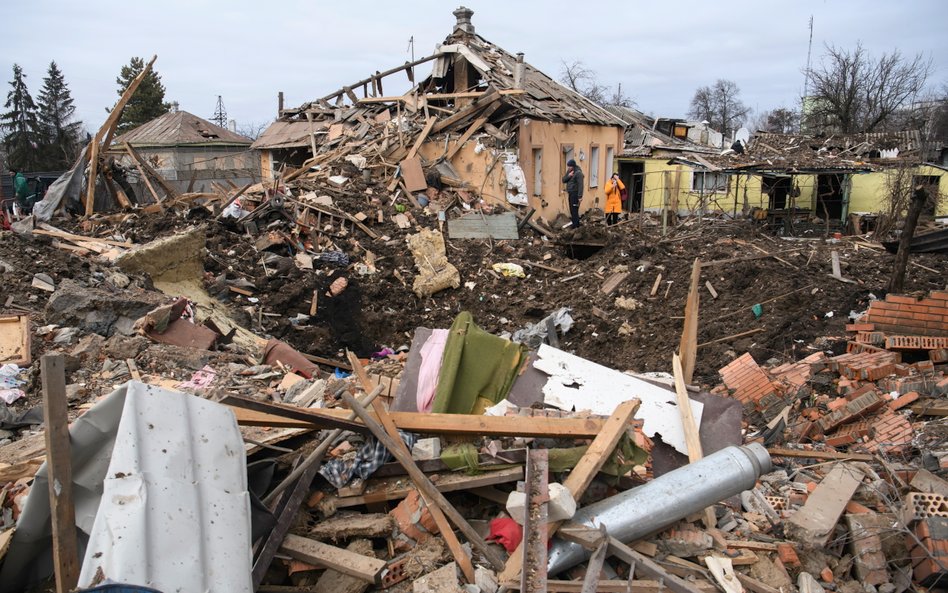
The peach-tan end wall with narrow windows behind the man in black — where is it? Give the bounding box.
[518,118,623,221]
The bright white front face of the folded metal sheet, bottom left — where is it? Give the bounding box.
[79,382,252,593]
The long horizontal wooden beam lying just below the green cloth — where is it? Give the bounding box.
[222,395,605,439]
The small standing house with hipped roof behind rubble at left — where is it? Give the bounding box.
[113,111,260,201]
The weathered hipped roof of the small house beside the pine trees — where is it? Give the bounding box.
[115,111,253,147]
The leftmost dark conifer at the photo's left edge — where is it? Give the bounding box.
[0,64,42,171]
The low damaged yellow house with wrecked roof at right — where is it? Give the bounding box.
[621,131,948,230]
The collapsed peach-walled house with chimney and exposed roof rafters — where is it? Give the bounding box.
[253,7,624,221]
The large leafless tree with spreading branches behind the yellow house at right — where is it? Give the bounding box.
[805,43,932,134]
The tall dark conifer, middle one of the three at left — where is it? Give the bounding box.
[38,62,82,171]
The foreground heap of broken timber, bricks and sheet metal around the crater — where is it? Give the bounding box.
[0,202,948,593]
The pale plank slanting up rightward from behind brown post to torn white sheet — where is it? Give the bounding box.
[498,399,640,581]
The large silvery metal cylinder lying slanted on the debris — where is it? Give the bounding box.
[547,443,773,576]
